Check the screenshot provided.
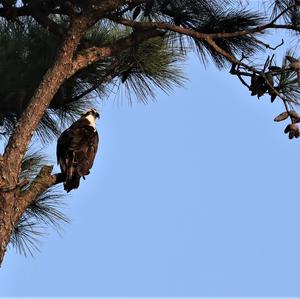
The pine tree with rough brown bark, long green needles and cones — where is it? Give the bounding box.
[0,0,300,264]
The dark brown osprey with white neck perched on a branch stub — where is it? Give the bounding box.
[56,109,99,192]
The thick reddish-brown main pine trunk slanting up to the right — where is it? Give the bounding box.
[0,19,87,265]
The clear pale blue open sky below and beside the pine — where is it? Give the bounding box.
[0,4,300,296]
